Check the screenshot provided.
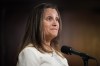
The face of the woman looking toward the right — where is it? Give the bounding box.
[43,8,59,39]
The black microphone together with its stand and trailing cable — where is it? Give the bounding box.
[61,46,98,66]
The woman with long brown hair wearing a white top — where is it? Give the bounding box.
[17,3,68,66]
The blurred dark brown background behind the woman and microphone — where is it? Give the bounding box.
[0,0,100,66]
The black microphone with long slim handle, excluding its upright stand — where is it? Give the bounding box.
[61,46,96,60]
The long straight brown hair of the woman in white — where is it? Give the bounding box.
[20,3,62,52]
